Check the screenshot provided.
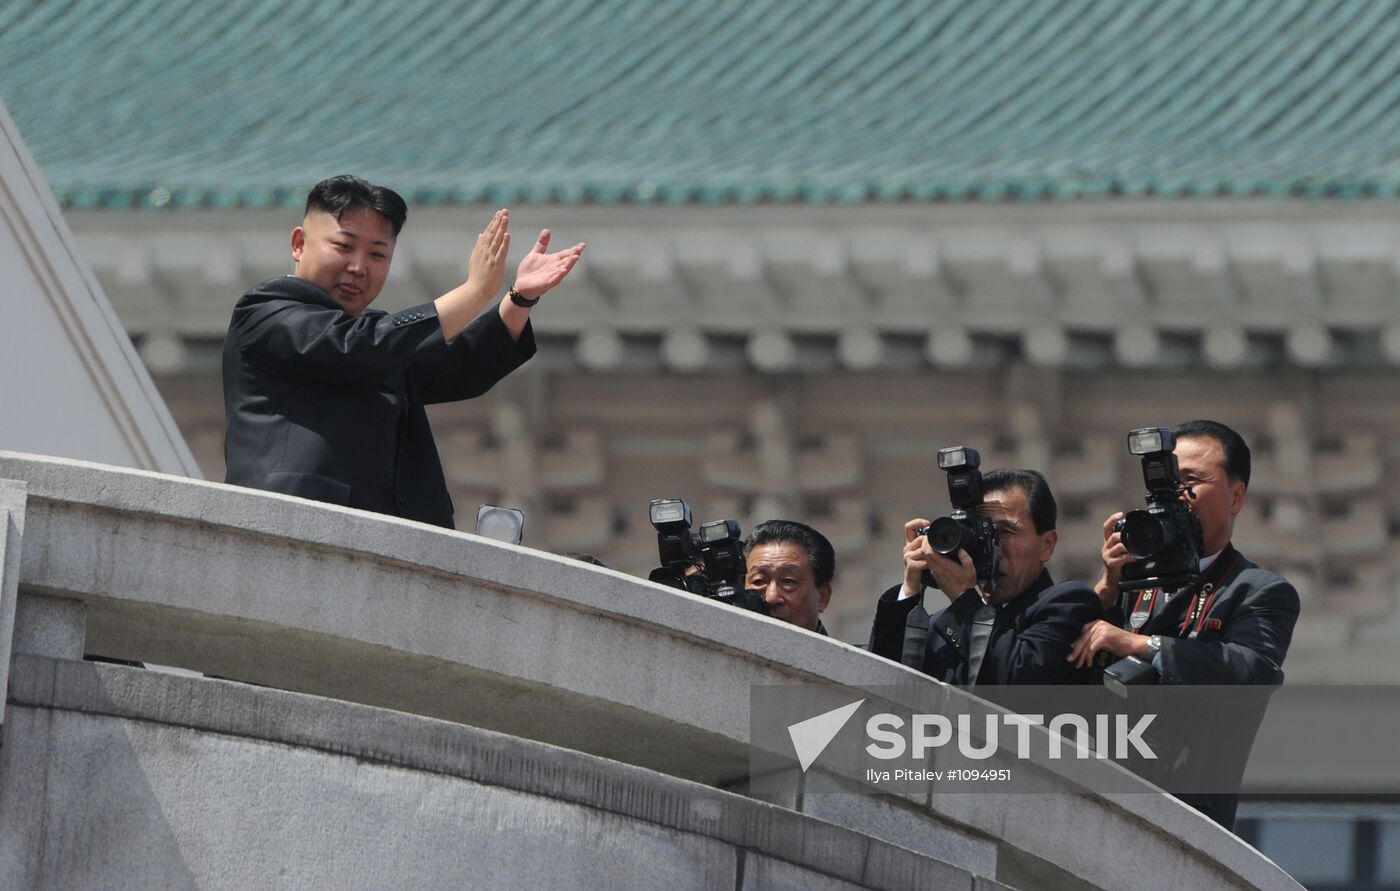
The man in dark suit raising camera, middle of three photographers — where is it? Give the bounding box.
[869,471,1100,686]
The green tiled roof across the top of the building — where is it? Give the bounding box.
[0,0,1400,207]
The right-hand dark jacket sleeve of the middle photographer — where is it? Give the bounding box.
[997,581,1103,684]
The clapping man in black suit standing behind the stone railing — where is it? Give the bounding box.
[223,177,584,528]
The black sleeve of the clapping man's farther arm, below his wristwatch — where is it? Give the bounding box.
[409,308,535,403]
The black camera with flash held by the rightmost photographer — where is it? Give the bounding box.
[1113,427,1203,591]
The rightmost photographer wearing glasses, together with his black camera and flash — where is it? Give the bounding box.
[1070,420,1299,828]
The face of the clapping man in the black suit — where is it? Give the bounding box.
[291,207,395,315]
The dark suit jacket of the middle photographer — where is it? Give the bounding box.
[871,570,1102,684]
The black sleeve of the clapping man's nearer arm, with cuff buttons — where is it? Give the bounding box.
[230,293,447,384]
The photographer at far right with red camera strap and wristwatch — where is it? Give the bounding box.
[1070,420,1299,828]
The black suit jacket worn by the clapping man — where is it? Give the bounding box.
[224,276,535,528]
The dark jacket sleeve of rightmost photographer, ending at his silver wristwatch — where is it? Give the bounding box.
[1161,569,1299,685]
